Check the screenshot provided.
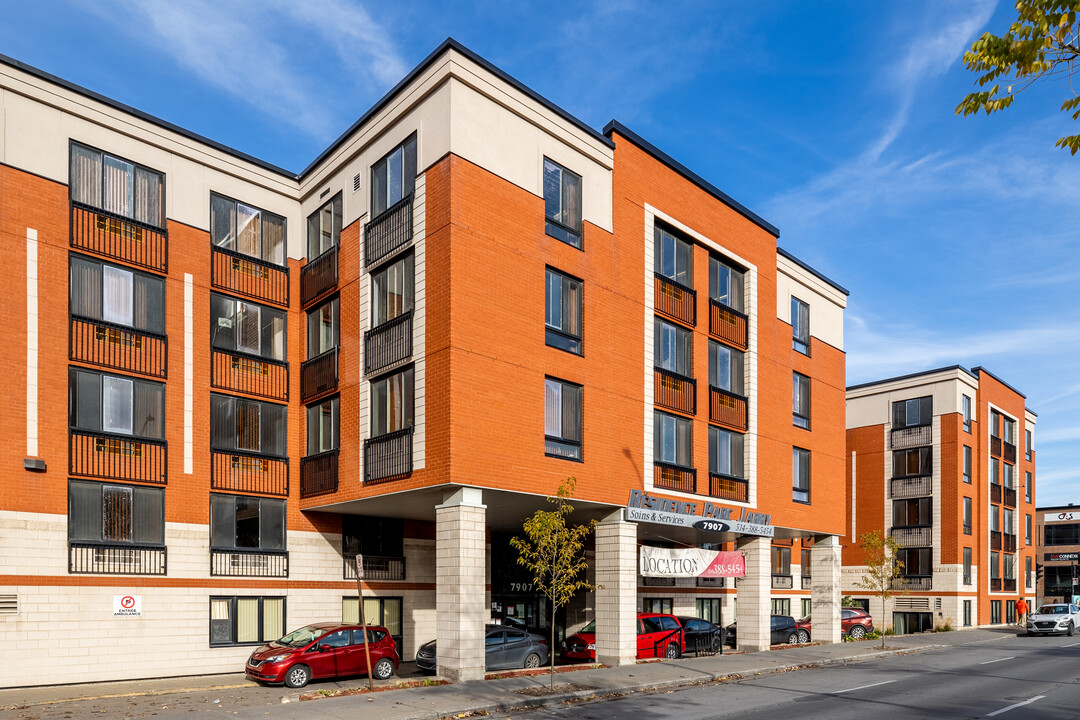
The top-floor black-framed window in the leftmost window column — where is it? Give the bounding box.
[70,142,165,228]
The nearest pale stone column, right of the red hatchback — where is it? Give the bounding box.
[435,488,489,682]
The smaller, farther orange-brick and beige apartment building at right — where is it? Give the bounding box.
[843,366,1036,633]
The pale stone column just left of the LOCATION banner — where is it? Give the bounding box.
[596,510,637,666]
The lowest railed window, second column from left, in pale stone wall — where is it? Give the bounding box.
[210,492,285,551]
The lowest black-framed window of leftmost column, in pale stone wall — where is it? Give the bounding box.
[68,480,165,545]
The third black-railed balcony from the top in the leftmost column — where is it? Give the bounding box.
[68,429,168,485]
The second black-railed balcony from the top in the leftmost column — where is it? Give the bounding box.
[68,315,168,378]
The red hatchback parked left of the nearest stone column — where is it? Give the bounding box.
[244,623,401,688]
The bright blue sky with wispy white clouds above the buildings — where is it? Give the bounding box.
[0,0,1080,505]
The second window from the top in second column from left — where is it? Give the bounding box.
[210,293,285,362]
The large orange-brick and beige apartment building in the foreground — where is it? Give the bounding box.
[0,40,847,687]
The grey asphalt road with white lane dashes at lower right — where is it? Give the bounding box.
[514,636,1080,720]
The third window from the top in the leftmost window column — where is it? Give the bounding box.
[69,368,165,439]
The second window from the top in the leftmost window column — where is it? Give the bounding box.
[70,255,165,335]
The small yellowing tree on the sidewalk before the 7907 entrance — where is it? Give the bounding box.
[510,477,596,689]
